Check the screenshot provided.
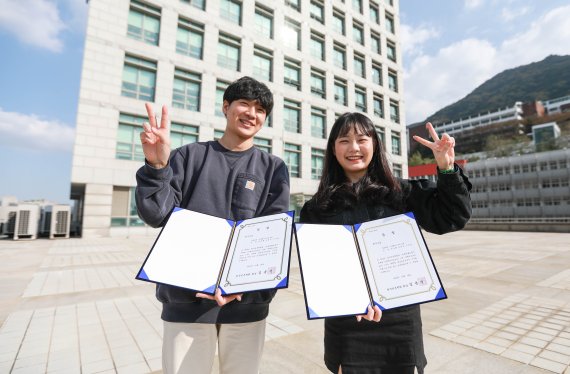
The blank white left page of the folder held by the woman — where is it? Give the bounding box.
[295,223,370,319]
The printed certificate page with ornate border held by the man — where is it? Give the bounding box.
[220,212,293,294]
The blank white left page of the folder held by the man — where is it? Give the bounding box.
[137,209,232,294]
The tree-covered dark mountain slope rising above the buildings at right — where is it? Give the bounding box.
[424,55,570,123]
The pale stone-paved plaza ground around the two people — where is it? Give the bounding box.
[0,231,570,374]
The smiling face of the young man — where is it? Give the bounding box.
[223,99,267,139]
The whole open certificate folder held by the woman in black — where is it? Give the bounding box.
[295,213,447,319]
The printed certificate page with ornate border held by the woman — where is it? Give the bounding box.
[356,214,446,309]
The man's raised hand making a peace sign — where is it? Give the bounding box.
[140,103,170,169]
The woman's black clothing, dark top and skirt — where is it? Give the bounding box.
[300,167,471,374]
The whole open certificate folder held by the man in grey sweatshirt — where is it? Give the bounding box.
[136,208,294,295]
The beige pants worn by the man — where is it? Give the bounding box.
[162,320,265,374]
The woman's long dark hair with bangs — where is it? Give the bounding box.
[313,113,402,211]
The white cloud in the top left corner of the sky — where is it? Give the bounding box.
[0,0,66,52]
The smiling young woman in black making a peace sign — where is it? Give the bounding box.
[300,113,471,374]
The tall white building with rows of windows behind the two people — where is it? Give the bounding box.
[71,0,407,236]
